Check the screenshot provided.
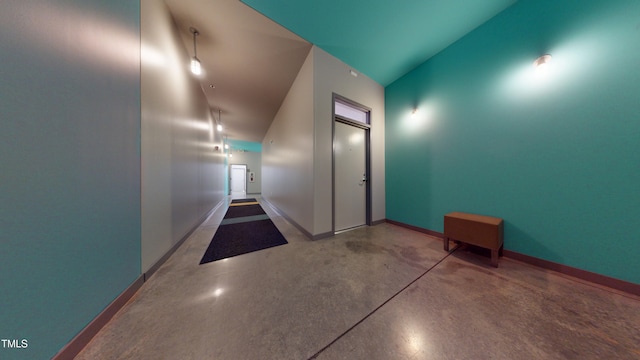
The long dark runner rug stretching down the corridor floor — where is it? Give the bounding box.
[200,199,287,265]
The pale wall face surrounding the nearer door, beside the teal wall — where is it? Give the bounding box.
[312,46,385,235]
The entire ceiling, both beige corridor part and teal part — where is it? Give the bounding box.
[165,0,516,146]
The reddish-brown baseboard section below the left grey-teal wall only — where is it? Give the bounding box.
[52,275,144,360]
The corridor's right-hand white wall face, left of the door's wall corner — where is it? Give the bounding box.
[262,47,313,233]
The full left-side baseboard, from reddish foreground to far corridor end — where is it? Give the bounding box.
[52,200,224,360]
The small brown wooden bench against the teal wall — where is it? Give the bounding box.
[444,212,503,267]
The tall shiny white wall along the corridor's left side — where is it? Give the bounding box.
[141,0,224,272]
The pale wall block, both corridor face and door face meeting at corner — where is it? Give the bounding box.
[262,46,385,236]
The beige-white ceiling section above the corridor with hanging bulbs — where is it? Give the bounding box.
[165,0,311,142]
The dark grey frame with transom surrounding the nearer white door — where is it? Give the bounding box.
[331,93,372,234]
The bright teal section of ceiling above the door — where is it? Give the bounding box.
[242,0,516,86]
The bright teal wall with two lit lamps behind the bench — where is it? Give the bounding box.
[385,0,640,283]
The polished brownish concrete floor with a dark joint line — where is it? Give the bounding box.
[77,198,640,359]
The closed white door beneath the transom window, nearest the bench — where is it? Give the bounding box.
[333,121,367,231]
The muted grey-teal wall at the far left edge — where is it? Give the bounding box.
[0,0,140,359]
